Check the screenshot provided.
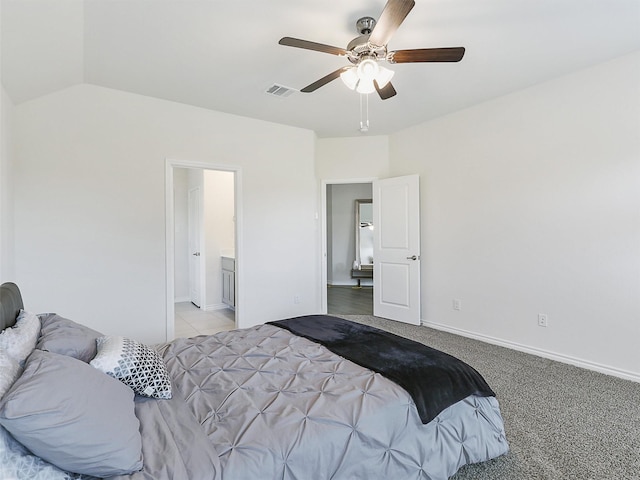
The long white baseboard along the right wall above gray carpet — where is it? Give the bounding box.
[421,320,640,383]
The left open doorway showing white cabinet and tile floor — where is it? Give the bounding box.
[167,161,239,340]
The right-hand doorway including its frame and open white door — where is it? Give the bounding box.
[321,175,421,325]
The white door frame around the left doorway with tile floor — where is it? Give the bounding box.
[165,158,244,341]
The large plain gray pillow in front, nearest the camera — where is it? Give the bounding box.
[0,350,142,477]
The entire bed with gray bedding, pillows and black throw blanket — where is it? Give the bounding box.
[0,284,509,480]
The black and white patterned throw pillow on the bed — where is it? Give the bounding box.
[90,335,171,399]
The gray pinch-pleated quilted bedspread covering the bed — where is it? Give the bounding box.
[115,325,508,480]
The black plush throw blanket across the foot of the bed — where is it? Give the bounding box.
[269,315,495,423]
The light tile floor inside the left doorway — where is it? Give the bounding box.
[174,302,236,338]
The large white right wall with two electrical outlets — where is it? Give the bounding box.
[390,53,640,379]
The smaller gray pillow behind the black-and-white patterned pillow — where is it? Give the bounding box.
[36,313,102,363]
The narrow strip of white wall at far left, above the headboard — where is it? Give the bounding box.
[0,87,15,282]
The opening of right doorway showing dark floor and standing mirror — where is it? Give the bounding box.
[326,182,373,315]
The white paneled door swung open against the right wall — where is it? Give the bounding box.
[373,175,420,325]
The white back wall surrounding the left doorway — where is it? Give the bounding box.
[13,85,320,342]
